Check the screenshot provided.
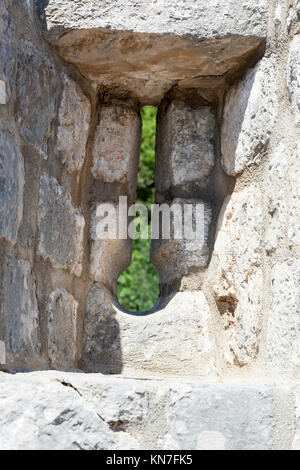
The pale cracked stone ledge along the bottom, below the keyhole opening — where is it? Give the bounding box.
[0,372,282,450]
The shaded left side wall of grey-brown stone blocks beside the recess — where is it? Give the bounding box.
[0,0,91,370]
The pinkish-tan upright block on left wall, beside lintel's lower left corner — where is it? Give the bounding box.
[57,75,91,172]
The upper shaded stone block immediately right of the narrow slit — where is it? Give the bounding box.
[156,100,216,197]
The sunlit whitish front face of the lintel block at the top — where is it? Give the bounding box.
[46,0,267,38]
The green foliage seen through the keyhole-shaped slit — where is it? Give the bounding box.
[118,106,159,312]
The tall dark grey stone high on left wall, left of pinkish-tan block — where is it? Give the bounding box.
[15,39,57,159]
